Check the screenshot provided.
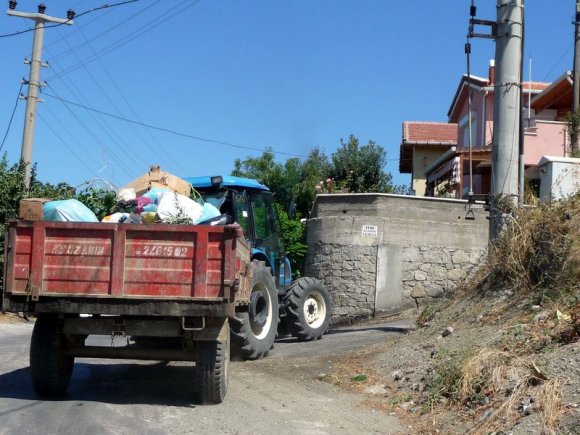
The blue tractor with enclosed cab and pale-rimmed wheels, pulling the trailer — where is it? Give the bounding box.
[185,176,331,359]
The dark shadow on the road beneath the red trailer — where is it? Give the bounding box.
[0,362,195,408]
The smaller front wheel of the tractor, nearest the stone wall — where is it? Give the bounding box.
[284,278,331,341]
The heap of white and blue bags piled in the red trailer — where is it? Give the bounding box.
[43,187,220,225]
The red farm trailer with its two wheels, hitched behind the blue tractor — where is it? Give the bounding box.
[2,221,255,403]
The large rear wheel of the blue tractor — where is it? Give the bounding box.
[230,260,278,360]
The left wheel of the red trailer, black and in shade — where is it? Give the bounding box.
[30,314,74,397]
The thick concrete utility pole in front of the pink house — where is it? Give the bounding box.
[490,0,524,241]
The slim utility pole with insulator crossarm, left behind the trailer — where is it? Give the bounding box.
[7,0,74,189]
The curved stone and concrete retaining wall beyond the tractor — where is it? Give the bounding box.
[306,194,488,323]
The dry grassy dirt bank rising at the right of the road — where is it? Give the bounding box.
[331,196,580,434]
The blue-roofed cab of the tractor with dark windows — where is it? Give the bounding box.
[185,176,292,293]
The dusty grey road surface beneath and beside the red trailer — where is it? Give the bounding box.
[0,323,405,435]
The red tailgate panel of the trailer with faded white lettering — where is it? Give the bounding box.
[4,221,239,300]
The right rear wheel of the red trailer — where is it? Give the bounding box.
[194,328,230,405]
